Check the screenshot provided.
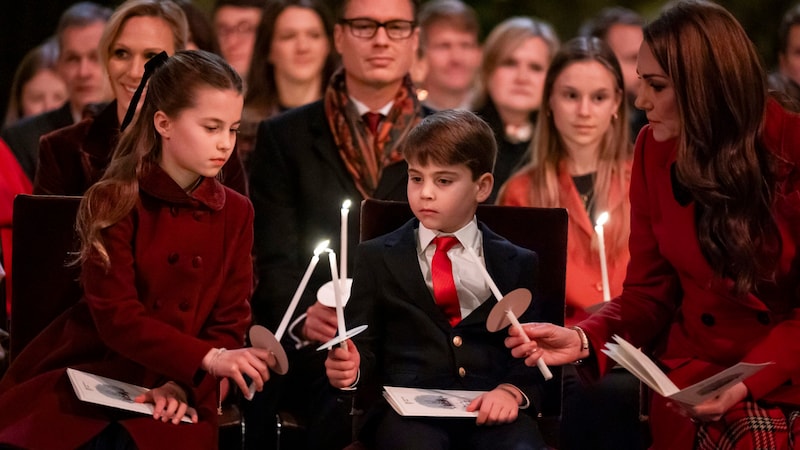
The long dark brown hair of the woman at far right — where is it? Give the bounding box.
[644,1,781,295]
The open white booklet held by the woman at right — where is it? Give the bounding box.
[601,335,772,406]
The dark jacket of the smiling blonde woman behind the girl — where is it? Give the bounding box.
[33,100,247,195]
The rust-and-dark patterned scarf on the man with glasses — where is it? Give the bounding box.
[325,69,422,198]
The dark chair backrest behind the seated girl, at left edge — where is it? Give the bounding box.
[9,195,81,360]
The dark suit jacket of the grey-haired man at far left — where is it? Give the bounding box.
[0,102,72,180]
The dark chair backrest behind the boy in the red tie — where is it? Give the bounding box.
[360,199,568,417]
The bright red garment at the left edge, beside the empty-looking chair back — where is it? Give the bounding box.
[0,140,33,317]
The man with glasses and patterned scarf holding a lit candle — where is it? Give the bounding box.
[248,0,423,449]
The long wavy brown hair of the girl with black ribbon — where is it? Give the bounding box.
[76,51,242,267]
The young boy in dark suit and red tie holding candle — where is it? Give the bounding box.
[325,110,545,449]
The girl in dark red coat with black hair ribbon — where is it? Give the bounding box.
[0,52,273,449]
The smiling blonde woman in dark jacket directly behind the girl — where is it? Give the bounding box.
[33,0,246,195]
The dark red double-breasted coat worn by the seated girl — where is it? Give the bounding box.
[0,167,253,449]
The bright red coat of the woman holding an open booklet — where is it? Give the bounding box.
[580,100,800,449]
